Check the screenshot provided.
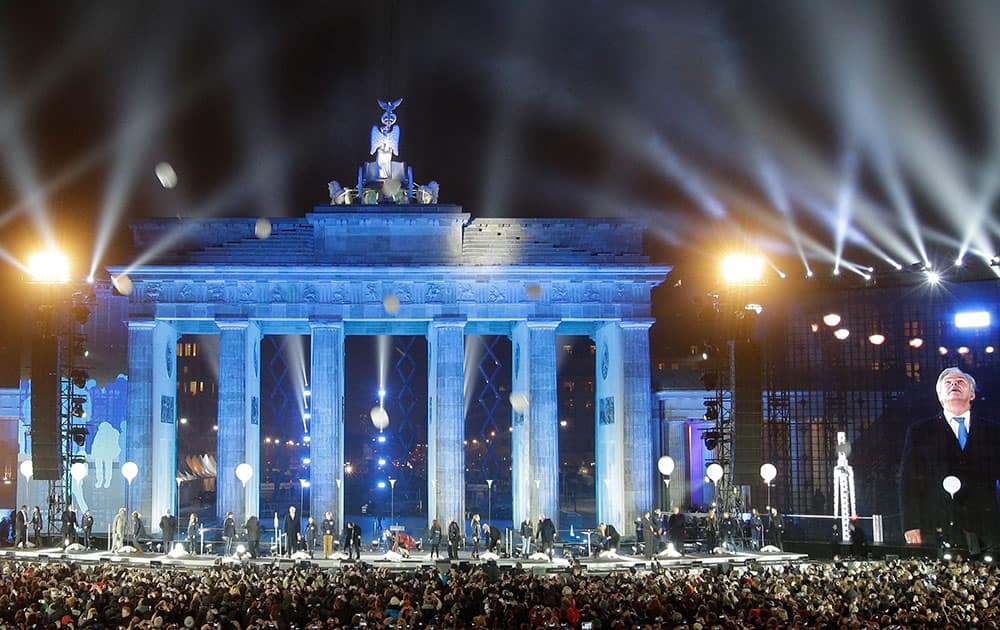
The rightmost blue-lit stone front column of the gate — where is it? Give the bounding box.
[621,319,656,523]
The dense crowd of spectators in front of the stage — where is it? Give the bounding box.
[0,560,1000,630]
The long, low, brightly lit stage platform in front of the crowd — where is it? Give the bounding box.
[0,547,809,574]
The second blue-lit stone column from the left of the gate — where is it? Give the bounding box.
[215,319,261,526]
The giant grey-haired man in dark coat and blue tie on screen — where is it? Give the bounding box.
[899,367,1000,554]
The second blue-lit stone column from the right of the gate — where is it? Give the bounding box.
[511,319,559,527]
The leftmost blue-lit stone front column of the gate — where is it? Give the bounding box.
[122,319,159,522]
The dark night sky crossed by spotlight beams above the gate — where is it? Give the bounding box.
[0,0,1000,372]
